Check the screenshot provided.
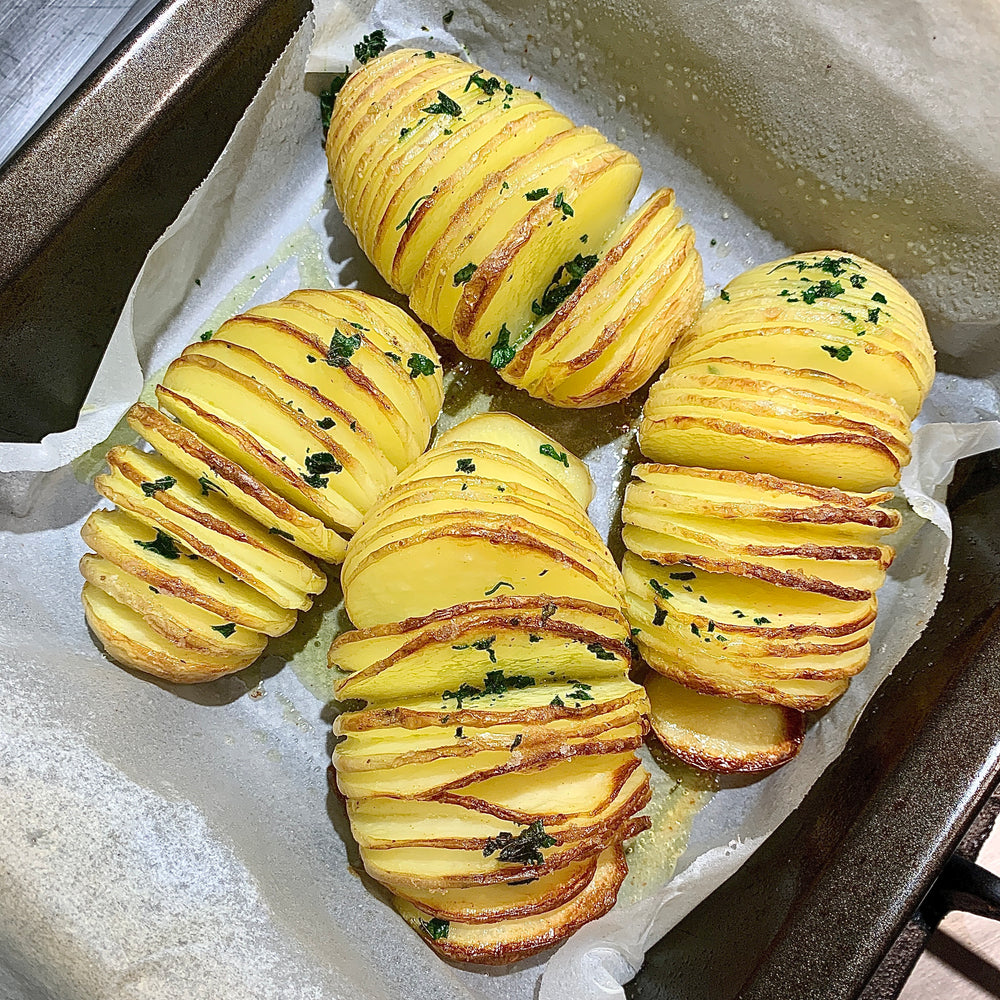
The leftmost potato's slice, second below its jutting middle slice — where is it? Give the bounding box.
[80,510,295,635]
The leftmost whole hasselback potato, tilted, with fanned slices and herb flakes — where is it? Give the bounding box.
[80,289,442,683]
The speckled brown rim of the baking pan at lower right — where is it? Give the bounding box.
[739,608,1000,1000]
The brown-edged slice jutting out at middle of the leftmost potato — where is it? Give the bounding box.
[127,403,347,568]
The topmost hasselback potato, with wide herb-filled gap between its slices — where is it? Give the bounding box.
[326,49,704,407]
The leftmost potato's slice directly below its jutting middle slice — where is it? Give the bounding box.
[94,448,326,610]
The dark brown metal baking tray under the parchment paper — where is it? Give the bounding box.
[0,0,1000,1000]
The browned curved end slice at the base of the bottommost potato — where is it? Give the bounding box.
[394,848,628,965]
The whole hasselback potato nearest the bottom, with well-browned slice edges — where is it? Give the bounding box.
[330,413,650,964]
